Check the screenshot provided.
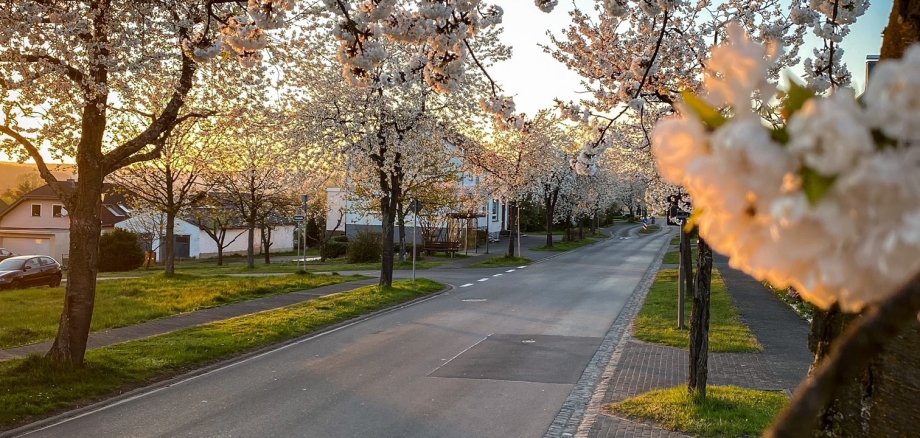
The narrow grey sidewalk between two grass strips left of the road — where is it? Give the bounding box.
[0,278,379,362]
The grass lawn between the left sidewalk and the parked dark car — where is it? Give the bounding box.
[0,274,363,348]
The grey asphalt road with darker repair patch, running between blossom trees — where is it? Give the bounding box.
[19,229,667,437]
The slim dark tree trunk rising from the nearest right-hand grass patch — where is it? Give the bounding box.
[687,237,712,397]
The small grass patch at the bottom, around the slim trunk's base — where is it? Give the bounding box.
[605,385,788,437]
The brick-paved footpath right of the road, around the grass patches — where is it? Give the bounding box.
[576,250,812,438]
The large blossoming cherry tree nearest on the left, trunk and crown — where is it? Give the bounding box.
[0,0,293,365]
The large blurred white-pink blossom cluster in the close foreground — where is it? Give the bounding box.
[653,27,920,311]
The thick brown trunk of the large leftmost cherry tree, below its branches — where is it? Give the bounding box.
[47,173,103,366]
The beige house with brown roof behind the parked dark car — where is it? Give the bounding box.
[0,180,128,261]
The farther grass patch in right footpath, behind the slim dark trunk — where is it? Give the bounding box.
[633,269,762,352]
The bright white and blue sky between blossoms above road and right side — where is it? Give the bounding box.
[489,0,892,115]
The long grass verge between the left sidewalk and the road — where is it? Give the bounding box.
[0,279,443,430]
